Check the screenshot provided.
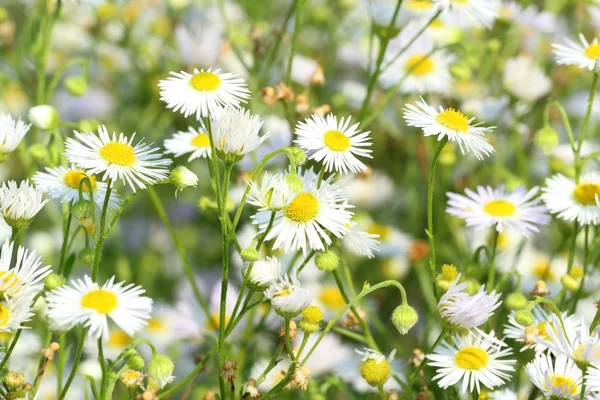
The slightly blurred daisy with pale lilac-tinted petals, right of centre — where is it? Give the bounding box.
[446,186,550,237]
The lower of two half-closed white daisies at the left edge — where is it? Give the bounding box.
[0,180,48,229]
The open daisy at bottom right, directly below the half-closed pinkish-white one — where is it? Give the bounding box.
[427,331,516,393]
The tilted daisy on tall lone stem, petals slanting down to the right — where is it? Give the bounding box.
[404,99,494,160]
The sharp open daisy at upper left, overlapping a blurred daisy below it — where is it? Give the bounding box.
[65,126,171,192]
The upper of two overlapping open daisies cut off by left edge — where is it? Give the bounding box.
[0,239,52,299]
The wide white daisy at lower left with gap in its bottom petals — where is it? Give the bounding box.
[46,275,152,339]
